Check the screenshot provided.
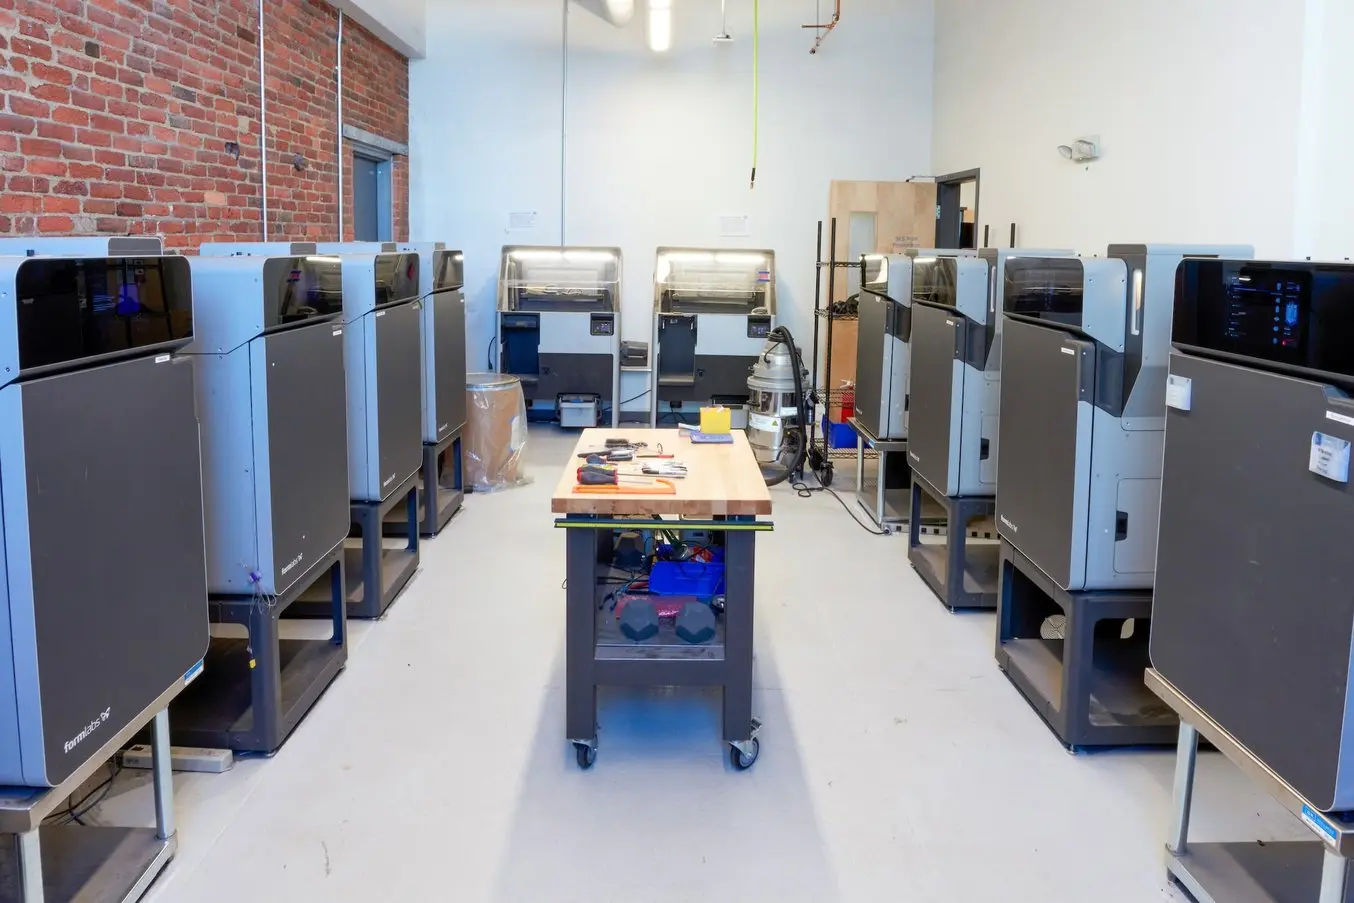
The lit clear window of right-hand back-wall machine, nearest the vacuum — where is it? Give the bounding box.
[655,248,776,314]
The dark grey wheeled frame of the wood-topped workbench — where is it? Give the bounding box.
[555,514,772,768]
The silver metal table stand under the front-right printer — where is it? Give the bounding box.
[1145,669,1354,903]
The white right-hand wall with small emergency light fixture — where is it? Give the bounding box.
[934,0,1305,256]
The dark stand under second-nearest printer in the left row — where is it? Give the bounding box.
[172,544,348,754]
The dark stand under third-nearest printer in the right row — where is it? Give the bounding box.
[907,470,1001,612]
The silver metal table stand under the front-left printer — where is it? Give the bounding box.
[0,680,184,903]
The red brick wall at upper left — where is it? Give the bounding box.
[0,0,409,250]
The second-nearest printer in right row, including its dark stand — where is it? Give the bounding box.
[997,245,1251,747]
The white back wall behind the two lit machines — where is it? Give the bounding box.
[410,0,933,409]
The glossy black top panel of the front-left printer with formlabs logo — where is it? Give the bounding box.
[15,257,192,371]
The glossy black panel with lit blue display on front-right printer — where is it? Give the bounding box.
[1171,260,1354,382]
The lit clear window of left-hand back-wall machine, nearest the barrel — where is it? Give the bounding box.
[498,248,620,311]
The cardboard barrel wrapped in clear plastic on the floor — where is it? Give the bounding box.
[462,374,527,493]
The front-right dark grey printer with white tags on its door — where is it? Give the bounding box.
[1151,260,1354,811]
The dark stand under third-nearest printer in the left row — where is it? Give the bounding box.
[287,471,422,619]
